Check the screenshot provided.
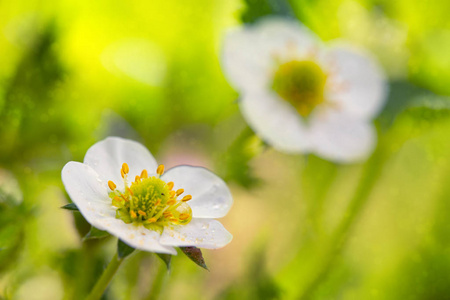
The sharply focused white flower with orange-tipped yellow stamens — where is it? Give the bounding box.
[62,137,233,255]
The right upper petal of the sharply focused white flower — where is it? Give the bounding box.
[161,166,233,218]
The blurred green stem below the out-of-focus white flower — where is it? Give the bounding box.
[298,145,386,299]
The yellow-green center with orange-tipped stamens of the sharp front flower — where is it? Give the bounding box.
[108,163,192,233]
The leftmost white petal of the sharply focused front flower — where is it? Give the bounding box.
[61,161,115,229]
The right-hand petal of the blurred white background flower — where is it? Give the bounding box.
[326,47,388,120]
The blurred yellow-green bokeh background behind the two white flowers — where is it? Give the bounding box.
[0,0,450,299]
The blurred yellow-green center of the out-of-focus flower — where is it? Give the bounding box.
[272,60,327,117]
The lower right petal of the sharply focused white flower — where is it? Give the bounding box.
[160,219,233,249]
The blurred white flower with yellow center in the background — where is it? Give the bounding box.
[223,18,387,162]
